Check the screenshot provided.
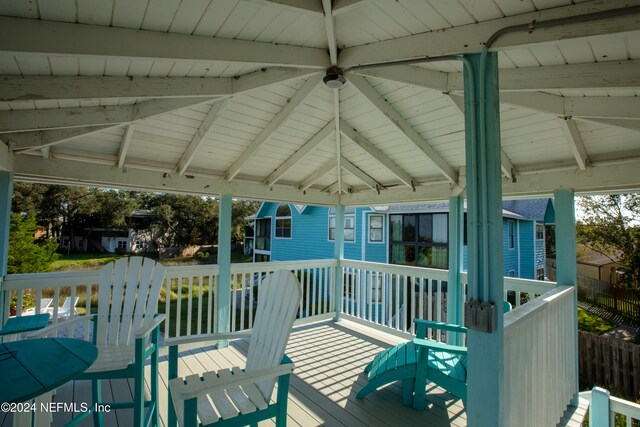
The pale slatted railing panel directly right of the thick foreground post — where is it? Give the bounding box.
[504,286,578,426]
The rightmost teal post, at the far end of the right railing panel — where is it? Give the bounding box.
[553,188,580,406]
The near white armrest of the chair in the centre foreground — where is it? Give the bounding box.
[169,363,294,400]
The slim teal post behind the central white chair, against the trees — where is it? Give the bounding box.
[216,194,233,348]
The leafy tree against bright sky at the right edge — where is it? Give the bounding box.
[577,194,640,287]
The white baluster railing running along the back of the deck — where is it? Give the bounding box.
[4,259,555,346]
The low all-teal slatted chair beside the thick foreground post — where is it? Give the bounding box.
[356,301,511,410]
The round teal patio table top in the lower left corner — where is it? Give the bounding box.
[0,338,98,403]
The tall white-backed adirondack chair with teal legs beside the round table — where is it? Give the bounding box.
[31,257,164,427]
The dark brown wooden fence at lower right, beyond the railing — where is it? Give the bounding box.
[578,331,640,400]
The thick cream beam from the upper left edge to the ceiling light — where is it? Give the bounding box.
[0,16,329,69]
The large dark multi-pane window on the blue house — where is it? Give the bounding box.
[389,214,449,269]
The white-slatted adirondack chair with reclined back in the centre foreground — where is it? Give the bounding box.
[168,270,301,426]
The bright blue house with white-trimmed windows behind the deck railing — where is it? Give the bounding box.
[253,199,554,280]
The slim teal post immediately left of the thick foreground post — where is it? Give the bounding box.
[447,196,464,345]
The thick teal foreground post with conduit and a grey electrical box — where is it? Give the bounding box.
[460,50,504,427]
